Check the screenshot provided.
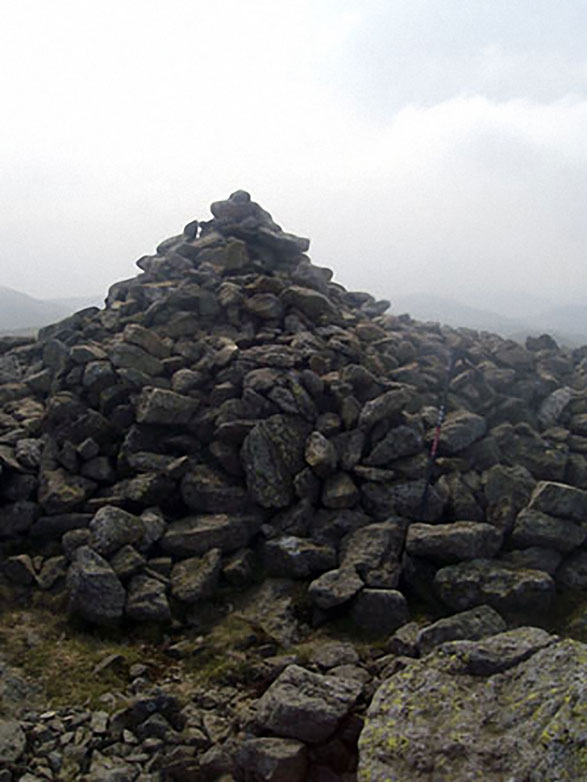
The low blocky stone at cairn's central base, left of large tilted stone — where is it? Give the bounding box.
[263,535,336,578]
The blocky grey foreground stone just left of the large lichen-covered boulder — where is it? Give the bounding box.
[255,665,362,744]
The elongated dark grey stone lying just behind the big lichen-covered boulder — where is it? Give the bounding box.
[416,605,506,655]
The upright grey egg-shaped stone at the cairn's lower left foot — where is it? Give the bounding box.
[67,546,126,624]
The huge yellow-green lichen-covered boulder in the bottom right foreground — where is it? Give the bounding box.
[358,628,587,782]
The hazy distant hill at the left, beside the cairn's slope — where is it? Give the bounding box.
[0,286,102,334]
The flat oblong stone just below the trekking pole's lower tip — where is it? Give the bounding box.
[406,521,503,562]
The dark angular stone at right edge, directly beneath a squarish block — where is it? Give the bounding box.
[512,507,587,554]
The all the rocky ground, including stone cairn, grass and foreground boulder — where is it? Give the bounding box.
[0,191,587,782]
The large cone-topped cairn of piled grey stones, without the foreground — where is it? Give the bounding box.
[0,191,587,634]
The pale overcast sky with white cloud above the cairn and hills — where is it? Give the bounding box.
[0,0,587,312]
